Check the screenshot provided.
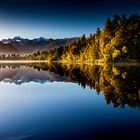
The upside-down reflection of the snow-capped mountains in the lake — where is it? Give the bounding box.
[0,64,71,85]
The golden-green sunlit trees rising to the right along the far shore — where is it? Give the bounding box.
[28,14,140,62]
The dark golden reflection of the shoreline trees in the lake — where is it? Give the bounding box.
[0,63,140,109]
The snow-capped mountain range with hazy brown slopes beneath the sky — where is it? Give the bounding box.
[0,36,79,55]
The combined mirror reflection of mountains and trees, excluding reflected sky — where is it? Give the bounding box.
[0,63,140,109]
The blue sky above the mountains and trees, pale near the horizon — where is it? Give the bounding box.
[0,0,140,39]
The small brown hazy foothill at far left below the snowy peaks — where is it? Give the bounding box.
[0,42,19,55]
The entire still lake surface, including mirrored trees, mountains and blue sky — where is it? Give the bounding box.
[0,63,140,140]
